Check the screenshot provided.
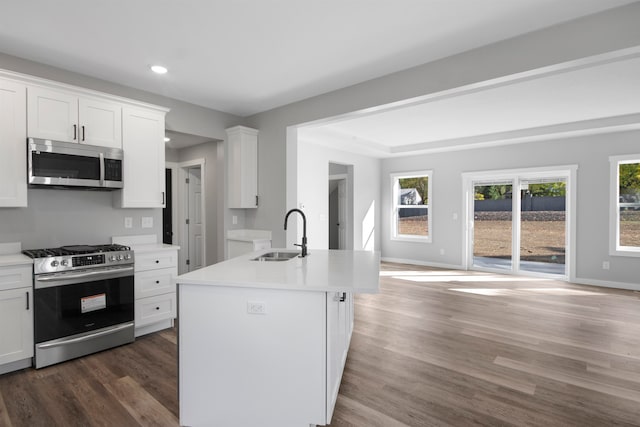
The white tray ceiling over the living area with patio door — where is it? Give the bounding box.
[299,53,640,157]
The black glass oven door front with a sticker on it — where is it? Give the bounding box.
[34,276,134,343]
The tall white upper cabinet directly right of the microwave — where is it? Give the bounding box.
[118,107,165,208]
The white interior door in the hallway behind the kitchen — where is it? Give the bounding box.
[187,167,204,271]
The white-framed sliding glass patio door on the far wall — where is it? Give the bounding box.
[465,168,575,279]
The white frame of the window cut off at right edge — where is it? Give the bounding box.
[609,154,640,257]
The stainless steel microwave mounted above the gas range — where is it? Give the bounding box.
[27,138,123,190]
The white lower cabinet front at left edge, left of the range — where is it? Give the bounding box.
[0,265,33,374]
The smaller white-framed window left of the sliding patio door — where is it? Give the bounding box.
[391,171,432,242]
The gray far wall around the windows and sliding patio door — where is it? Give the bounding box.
[381,131,640,289]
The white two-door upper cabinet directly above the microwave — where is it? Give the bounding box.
[27,86,122,148]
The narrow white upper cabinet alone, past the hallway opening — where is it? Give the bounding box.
[226,126,258,209]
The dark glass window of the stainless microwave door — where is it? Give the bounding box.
[32,151,100,180]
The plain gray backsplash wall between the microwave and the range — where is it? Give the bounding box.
[0,189,162,249]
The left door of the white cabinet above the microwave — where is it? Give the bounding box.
[27,87,79,142]
